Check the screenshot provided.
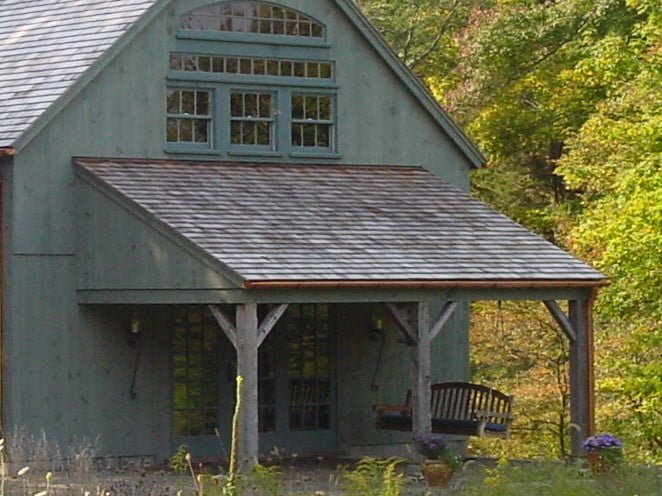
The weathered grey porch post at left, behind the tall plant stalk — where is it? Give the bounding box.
[236,303,259,473]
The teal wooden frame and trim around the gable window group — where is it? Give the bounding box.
[166,2,341,160]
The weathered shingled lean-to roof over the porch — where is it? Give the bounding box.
[75,159,604,287]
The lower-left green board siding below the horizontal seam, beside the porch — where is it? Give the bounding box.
[4,257,169,457]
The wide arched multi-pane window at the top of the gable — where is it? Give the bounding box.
[181,1,324,38]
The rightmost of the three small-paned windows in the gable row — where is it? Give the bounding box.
[292,94,334,148]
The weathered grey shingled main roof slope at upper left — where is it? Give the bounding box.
[0,0,156,147]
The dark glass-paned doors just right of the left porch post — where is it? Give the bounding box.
[258,304,336,453]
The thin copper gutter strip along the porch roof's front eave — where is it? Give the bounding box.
[244,279,609,290]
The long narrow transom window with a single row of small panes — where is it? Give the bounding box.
[170,53,333,79]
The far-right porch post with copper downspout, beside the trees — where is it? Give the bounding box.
[568,296,595,456]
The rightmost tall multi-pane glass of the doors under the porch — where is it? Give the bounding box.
[287,305,331,431]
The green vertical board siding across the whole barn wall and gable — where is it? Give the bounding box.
[4,0,478,459]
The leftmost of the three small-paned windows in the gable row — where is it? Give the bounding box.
[166,88,212,145]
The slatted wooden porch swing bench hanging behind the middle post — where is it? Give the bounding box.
[373,382,514,437]
